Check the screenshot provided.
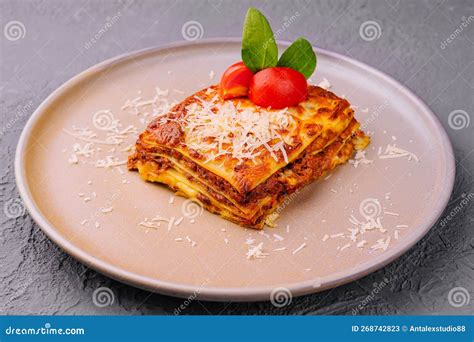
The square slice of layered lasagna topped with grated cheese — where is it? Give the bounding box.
[128,86,369,229]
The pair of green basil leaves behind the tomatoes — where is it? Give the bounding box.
[242,7,316,78]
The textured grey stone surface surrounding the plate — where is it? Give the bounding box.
[0,0,474,315]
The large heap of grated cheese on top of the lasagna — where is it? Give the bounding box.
[168,96,294,163]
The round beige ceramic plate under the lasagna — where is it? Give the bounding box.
[16,40,454,301]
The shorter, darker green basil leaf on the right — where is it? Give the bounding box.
[278,37,316,78]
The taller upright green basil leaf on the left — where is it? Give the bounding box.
[242,7,278,72]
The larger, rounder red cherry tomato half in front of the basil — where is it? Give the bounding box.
[249,67,308,109]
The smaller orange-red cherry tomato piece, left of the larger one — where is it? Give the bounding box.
[219,62,253,100]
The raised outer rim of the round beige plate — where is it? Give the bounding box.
[15,38,455,302]
